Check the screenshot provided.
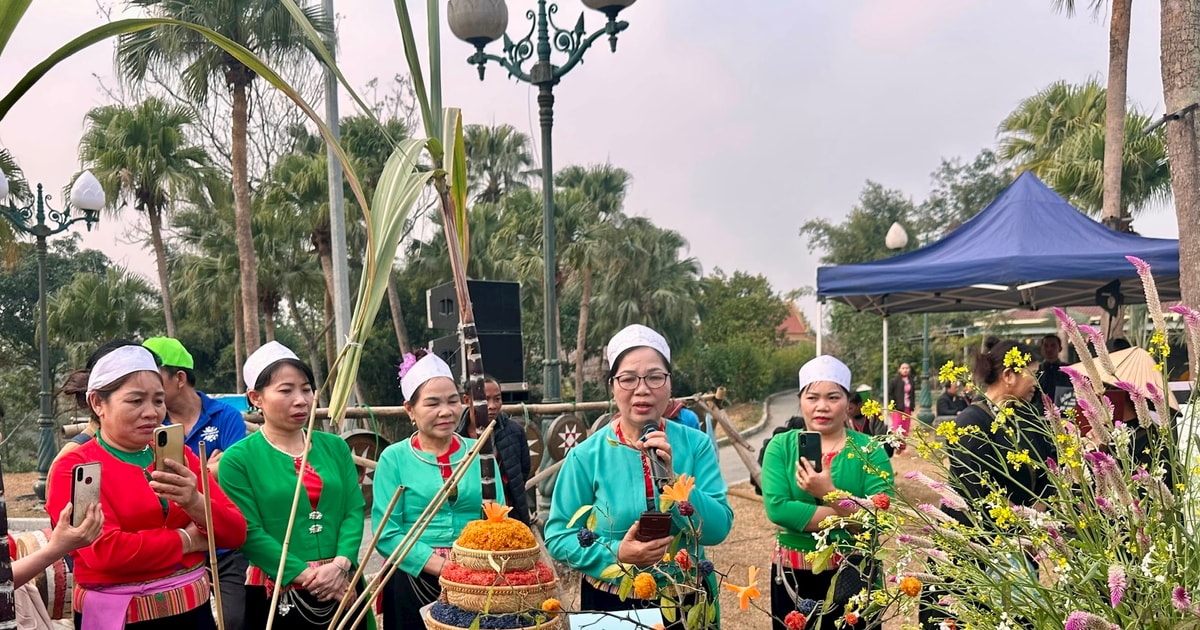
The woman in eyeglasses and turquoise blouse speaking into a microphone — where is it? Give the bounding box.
[546,324,733,628]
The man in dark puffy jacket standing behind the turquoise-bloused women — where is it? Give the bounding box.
[458,376,532,524]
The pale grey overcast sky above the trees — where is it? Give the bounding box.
[0,0,1177,318]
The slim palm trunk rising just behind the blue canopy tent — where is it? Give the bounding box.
[1052,0,1142,230]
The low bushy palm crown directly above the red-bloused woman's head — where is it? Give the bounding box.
[47,266,162,365]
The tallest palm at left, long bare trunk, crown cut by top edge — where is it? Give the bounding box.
[116,0,332,352]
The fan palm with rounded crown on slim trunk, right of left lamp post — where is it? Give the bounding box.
[79,97,215,337]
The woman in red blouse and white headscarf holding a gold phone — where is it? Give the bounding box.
[46,344,246,630]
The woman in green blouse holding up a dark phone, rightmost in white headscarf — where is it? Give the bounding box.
[762,355,894,630]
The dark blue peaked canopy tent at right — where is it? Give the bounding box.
[817,170,1180,402]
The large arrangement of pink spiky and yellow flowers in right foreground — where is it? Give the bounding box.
[816,258,1200,630]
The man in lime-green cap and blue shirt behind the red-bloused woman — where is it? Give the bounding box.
[142,337,248,630]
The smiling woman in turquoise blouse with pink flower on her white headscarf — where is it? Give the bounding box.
[371,349,502,629]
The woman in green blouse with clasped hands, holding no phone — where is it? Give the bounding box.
[221,341,365,630]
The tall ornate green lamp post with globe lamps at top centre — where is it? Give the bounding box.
[446,0,635,402]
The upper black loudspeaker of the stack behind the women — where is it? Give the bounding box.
[425,280,521,333]
